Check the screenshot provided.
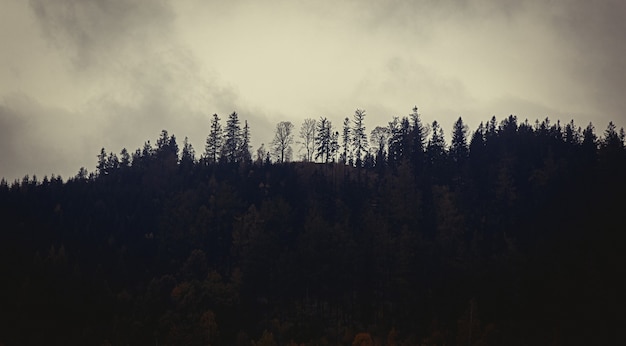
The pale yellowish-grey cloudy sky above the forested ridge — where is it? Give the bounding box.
[0,0,626,182]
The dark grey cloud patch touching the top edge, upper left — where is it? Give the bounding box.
[30,0,175,69]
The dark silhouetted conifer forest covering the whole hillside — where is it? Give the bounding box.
[0,108,626,346]
